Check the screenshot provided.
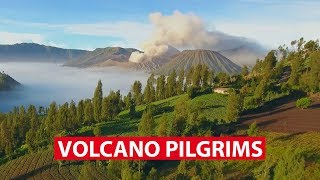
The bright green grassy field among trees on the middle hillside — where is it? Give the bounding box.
[78,93,227,136]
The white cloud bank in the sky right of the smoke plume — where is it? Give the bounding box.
[215,21,320,49]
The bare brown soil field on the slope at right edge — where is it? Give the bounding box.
[241,96,320,133]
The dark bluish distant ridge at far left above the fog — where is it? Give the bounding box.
[0,43,88,63]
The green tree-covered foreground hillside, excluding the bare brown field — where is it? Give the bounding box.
[0,39,320,179]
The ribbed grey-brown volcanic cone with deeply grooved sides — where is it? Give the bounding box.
[155,50,241,74]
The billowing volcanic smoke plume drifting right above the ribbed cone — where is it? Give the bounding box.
[129,11,264,64]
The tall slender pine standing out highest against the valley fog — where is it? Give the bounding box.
[93,80,103,122]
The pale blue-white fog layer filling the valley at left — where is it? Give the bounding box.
[0,63,148,112]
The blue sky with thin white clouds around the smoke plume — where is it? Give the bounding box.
[0,0,320,49]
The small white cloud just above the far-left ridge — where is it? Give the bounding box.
[0,31,44,44]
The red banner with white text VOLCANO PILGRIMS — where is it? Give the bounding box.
[54,136,266,160]
